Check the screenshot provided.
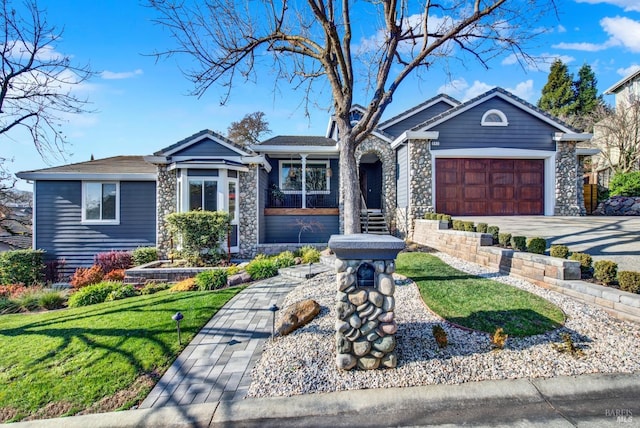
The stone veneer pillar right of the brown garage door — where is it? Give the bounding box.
[554,141,586,216]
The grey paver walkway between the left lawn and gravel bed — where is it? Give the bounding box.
[140,268,308,409]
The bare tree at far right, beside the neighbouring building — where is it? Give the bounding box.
[593,97,640,173]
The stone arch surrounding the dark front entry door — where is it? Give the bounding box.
[356,137,396,231]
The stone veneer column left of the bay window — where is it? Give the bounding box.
[156,165,177,259]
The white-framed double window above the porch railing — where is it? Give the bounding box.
[280,161,330,193]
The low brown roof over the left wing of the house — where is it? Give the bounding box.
[16,156,156,180]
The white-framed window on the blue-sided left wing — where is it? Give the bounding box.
[82,182,120,224]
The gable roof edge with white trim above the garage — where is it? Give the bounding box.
[411,87,580,134]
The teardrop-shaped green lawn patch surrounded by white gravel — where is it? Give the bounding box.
[396,252,564,337]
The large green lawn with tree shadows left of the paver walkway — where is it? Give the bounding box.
[0,287,242,422]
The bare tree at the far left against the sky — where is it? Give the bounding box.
[0,0,92,158]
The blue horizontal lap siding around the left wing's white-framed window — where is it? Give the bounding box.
[35,181,156,268]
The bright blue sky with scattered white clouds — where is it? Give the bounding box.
[0,0,640,190]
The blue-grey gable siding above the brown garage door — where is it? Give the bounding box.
[430,98,559,151]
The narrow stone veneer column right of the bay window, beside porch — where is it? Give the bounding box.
[238,164,259,258]
